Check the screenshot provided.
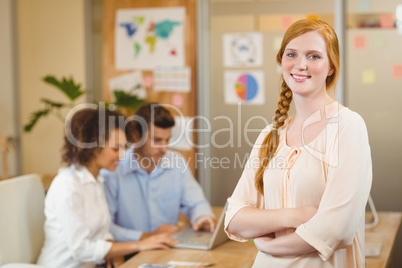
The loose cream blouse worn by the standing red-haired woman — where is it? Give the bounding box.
[225,108,372,268]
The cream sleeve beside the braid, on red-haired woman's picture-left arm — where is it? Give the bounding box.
[225,126,271,242]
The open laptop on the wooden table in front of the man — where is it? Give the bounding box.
[171,202,229,250]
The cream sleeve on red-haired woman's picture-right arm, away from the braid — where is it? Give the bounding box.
[296,112,372,261]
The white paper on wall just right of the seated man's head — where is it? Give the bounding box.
[169,116,194,151]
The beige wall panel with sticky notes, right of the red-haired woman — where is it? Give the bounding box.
[345,0,402,267]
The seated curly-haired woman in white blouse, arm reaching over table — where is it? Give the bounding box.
[38,109,174,268]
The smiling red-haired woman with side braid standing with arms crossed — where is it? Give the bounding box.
[225,19,372,268]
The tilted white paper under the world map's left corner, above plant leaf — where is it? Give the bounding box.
[109,71,147,99]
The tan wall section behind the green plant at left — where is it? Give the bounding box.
[17,0,85,174]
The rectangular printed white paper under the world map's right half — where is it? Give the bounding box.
[154,67,191,92]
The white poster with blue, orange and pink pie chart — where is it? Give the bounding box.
[224,71,265,105]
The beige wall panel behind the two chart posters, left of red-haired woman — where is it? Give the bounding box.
[209,0,334,205]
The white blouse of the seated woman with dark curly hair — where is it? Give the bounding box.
[38,165,113,268]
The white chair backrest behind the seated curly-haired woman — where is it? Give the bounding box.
[0,174,45,266]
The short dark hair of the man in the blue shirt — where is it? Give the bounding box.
[134,102,175,138]
